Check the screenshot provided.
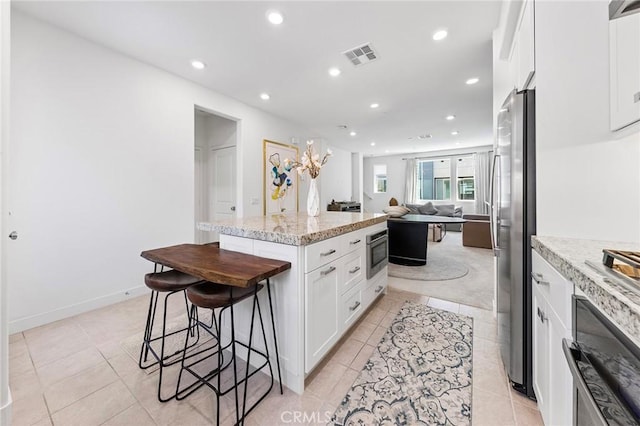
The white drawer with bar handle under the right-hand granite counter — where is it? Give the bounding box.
[531,251,573,329]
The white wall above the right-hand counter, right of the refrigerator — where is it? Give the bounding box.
[535,1,640,242]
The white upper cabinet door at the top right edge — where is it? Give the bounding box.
[609,13,640,130]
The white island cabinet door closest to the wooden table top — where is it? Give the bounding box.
[305,261,340,372]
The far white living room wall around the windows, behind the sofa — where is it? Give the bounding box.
[363,146,491,213]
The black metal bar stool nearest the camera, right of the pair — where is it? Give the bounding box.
[176,279,283,424]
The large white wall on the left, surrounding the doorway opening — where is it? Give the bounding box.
[8,11,310,331]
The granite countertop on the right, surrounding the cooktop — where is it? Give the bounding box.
[531,236,640,344]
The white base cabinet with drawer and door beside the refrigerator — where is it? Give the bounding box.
[532,251,573,425]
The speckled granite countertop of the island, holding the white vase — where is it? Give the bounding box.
[197,212,388,246]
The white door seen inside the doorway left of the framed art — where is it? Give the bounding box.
[209,146,237,225]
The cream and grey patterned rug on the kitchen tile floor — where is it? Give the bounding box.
[332,302,473,426]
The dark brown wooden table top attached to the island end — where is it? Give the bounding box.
[140,244,291,287]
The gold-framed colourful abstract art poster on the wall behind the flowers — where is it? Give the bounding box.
[262,139,299,215]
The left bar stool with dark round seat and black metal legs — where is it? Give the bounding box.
[138,265,203,402]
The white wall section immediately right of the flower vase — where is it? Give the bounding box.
[320,146,352,206]
